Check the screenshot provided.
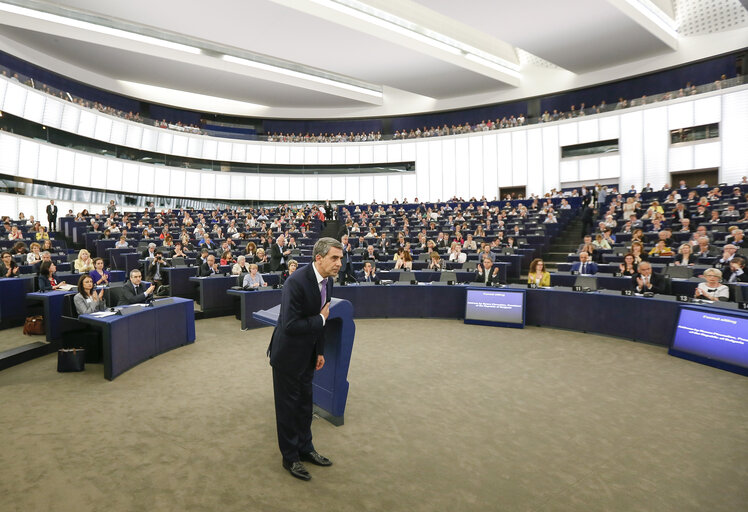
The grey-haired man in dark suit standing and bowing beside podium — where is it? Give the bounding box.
[268,238,343,480]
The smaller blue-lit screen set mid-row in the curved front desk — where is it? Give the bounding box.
[465,288,525,329]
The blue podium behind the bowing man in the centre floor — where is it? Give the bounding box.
[252,298,356,427]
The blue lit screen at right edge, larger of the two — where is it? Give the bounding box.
[669,307,748,375]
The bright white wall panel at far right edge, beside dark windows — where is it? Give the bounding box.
[719,90,748,183]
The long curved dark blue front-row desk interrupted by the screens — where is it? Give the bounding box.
[228,283,748,346]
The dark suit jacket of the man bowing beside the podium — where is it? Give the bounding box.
[268,263,332,376]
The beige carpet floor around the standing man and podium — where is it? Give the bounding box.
[0,317,748,512]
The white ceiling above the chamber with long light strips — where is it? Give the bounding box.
[0,0,748,117]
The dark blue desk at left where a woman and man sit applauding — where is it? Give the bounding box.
[78,297,195,380]
